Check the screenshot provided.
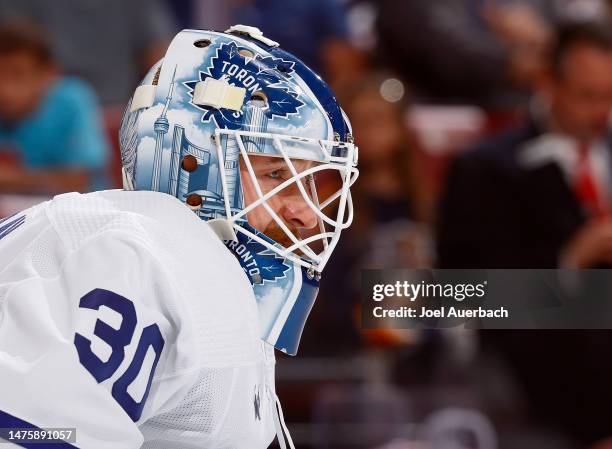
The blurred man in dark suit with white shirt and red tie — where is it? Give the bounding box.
[438,24,612,445]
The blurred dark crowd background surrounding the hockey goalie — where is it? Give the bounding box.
[0,0,612,449]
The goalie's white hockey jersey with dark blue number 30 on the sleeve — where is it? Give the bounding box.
[0,190,276,449]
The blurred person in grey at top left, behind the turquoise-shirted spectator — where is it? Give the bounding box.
[0,0,176,107]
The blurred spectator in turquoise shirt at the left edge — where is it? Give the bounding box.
[0,22,108,193]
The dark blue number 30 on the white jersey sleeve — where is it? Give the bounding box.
[74,288,164,421]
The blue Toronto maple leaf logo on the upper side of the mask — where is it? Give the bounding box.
[183,42,304,129]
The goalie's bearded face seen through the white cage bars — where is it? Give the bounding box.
[240,156,318,247]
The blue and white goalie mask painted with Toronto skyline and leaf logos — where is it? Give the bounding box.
[120,25,358,355]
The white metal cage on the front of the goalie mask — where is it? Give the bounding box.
[215,129,358,276]
